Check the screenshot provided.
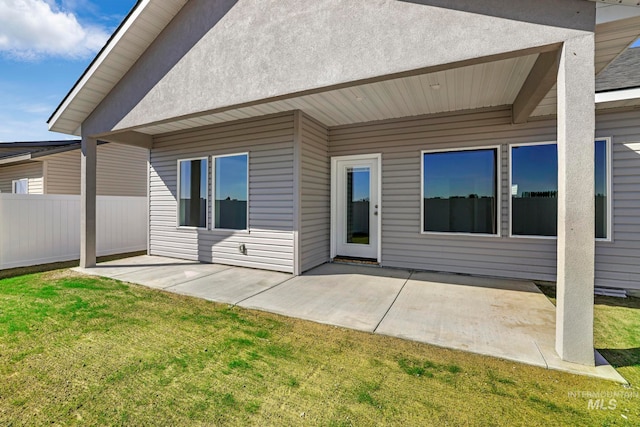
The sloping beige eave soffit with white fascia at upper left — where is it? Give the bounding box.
[48,0,187,135]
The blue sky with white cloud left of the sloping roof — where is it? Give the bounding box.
[0,0,136,142]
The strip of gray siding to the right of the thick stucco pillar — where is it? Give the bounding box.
[596,110,640,289]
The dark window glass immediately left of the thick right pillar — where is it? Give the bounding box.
[511,144,558,236]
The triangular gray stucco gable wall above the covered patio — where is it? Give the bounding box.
[82,0,595,135]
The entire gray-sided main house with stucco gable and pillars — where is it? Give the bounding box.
[49,0,640,365]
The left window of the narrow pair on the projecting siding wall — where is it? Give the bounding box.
[178,159,209,228]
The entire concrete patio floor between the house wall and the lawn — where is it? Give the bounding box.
[76,255,625,383]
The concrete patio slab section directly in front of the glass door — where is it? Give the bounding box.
[238,264,410,332]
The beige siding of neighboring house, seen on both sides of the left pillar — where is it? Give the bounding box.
[46,143,149,197]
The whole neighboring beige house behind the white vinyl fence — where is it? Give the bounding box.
[0,140,149,196]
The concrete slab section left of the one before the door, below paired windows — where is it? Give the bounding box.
[167,267,293,304]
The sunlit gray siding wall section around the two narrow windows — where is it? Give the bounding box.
[149,113,294,273]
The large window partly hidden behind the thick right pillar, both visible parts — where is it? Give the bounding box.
[511,139,610,239]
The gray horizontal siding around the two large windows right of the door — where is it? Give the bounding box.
[329,108,640,289]
